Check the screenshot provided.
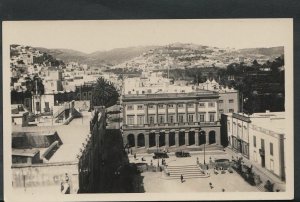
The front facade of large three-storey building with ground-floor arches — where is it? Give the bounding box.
[122,91,220,149]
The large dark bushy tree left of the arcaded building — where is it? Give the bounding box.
[92,77,119,108]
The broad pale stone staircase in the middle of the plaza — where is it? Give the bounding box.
[164,165,208,180]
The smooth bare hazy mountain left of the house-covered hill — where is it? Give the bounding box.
[36,46,158,66]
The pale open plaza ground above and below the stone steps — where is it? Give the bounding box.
[129,151,260,193]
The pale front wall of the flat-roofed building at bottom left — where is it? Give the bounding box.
[12,162,79,193]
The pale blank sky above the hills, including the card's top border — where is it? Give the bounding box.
[3,19,292,53]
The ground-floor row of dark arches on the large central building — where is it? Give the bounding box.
[123,128,220,148]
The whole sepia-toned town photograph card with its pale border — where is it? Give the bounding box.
[2,18,294,201]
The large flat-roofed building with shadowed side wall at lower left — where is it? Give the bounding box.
[11,107,107,194]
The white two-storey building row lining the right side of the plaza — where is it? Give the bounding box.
[222,111,286,180]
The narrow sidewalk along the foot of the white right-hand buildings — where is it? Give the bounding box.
[225,148,286,191]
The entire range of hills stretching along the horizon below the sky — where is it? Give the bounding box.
[36,43,284,66]
